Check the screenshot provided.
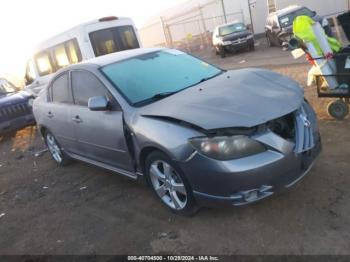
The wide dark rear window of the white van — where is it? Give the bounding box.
[89,26,140,56]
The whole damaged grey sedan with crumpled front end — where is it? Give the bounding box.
[33,48,321,214]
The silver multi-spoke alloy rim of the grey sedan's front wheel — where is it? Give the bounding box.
[149,160,187,210]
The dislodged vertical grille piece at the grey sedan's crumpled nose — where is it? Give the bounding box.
[294,106,315,154]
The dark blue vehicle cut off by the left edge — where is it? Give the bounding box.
[0,78,35,134]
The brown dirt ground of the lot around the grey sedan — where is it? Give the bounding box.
[0,44,350,254]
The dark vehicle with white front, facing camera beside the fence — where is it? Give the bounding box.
[213,22,254,57]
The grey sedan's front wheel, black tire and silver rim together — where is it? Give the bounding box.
[145,151,198,216]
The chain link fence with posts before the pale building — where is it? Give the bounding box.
[140,0,248,52]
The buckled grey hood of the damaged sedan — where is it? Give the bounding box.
[139,69,304,130]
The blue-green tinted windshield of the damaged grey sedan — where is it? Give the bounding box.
[102,49,223,106]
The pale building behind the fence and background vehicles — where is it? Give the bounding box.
[139,0,350,47]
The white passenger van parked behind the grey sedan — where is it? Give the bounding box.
[25,16,141,96]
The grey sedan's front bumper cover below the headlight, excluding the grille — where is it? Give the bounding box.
[181,134,322,207]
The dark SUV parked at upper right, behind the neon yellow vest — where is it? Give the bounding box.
[265,5,331,46]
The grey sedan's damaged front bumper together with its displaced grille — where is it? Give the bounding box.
[179,103,322,207]
